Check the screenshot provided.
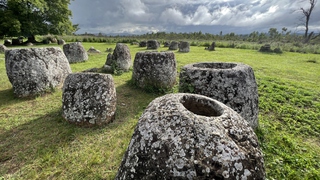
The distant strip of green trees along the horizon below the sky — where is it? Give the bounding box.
[71,28,320,44]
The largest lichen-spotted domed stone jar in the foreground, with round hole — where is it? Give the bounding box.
[115,93,265,180]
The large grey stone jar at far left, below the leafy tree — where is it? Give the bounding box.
[5,47,71,97]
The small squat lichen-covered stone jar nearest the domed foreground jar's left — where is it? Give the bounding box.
[62,73,116,127]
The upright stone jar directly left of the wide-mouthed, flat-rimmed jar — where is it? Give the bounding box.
[132,52,177,89]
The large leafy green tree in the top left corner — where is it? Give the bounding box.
[0,0,77,39]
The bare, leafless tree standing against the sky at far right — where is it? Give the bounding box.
[300,0,319,43]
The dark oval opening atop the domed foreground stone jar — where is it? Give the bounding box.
[180,95,223,117]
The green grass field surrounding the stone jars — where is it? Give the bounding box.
[0,43,320,179]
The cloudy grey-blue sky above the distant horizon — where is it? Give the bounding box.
[69,0,320,34]
